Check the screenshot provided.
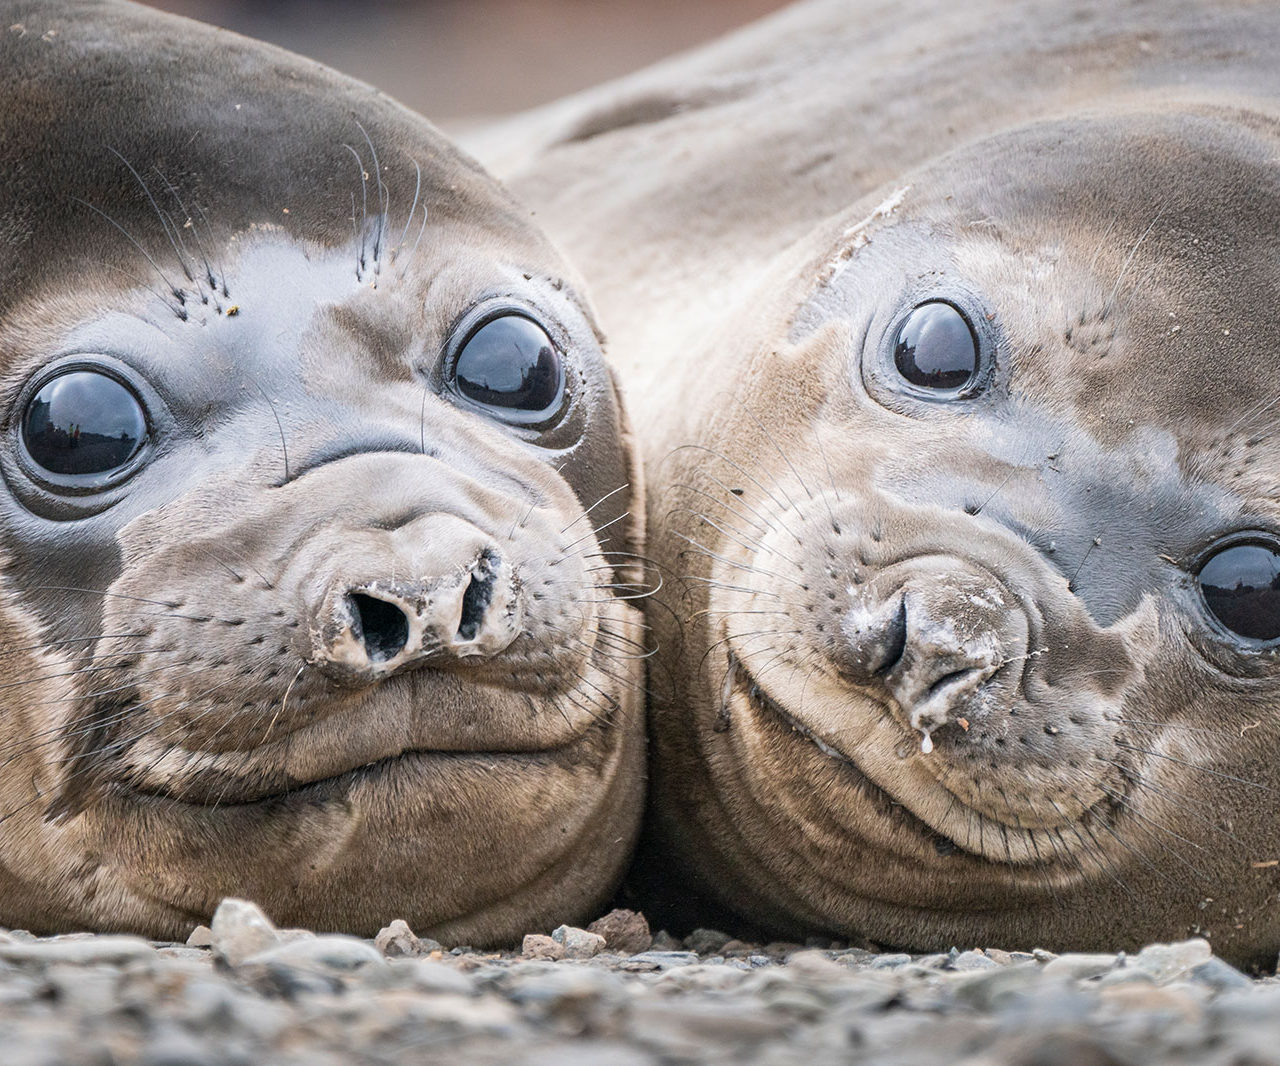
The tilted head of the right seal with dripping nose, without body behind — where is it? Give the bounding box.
[640,102,1280,960]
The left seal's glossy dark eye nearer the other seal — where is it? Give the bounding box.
[453,314,564,425]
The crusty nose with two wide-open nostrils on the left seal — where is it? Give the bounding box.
[312,548,522,682]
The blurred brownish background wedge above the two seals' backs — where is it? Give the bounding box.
[135,0,786,125]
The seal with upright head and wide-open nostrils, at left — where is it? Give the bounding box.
[0,0,643,943]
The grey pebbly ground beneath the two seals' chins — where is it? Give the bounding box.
[0,900,1280,1066]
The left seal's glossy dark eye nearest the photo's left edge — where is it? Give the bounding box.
[22,370,147,477]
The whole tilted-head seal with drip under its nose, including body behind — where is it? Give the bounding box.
[477,0,1280,961]
